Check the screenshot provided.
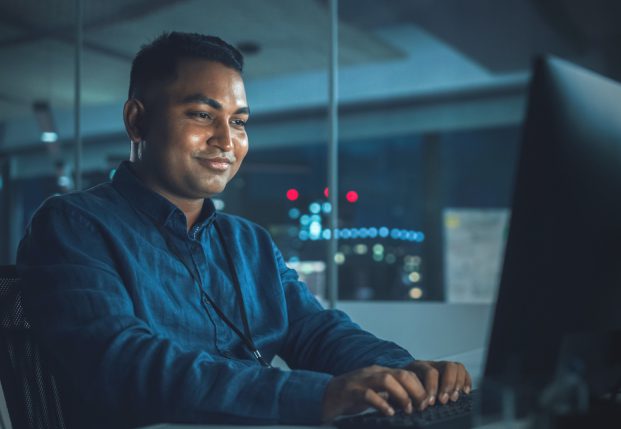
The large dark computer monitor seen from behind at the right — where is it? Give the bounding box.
[484,57,621,400]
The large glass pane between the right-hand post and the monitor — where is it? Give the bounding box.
[337,0,621,303]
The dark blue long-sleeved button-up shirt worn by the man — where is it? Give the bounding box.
[17,162,413,427]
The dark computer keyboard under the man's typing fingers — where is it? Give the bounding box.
[334,393,473,429]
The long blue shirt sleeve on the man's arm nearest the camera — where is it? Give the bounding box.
[18,199,330,427]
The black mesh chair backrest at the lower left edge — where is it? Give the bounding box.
[0,265,65,429]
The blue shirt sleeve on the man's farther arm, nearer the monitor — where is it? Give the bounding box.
[273,241,414,375]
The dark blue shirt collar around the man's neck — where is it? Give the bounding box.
[112,161,216,235]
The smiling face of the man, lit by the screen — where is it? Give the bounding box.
[136,59,249,202]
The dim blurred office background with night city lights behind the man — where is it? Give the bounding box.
[0,0,621,301]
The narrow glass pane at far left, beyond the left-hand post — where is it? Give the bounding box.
[0,0,75,264]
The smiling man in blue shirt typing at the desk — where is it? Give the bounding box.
[18,33,471,427]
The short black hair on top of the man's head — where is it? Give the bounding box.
[128,31,244,98]
